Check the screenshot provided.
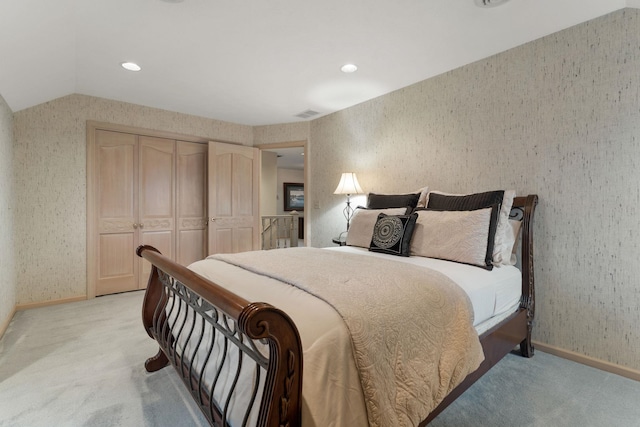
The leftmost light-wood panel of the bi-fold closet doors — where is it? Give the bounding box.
[93,130,138,295]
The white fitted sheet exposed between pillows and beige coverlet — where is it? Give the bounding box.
[326,246,522,330]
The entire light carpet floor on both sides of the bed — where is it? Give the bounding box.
[0,292,640,427]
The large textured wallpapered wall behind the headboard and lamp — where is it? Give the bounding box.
[307,9,640,370]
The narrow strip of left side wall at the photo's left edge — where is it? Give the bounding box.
[0,96,17,336]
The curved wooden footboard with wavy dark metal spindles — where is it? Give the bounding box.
[136,246,302,427]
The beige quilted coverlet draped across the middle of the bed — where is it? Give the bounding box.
[212,248,483,426]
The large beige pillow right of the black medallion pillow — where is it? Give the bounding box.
[411,207,493,269]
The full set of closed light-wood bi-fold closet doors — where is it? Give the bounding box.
[88,129,207,295]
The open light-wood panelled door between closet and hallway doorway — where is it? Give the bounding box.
[209,142,260,254]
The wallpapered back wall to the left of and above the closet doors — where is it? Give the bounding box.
[14,95,253,305]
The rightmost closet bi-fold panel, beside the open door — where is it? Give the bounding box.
[176,141,207,265]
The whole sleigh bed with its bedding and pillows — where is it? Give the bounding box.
[137,191,538,427]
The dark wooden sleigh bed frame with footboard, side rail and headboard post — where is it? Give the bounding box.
[136,195,538,427]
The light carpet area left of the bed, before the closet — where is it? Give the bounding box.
[0,292,208,427]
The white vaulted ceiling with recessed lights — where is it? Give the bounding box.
[0,0,640,125]
